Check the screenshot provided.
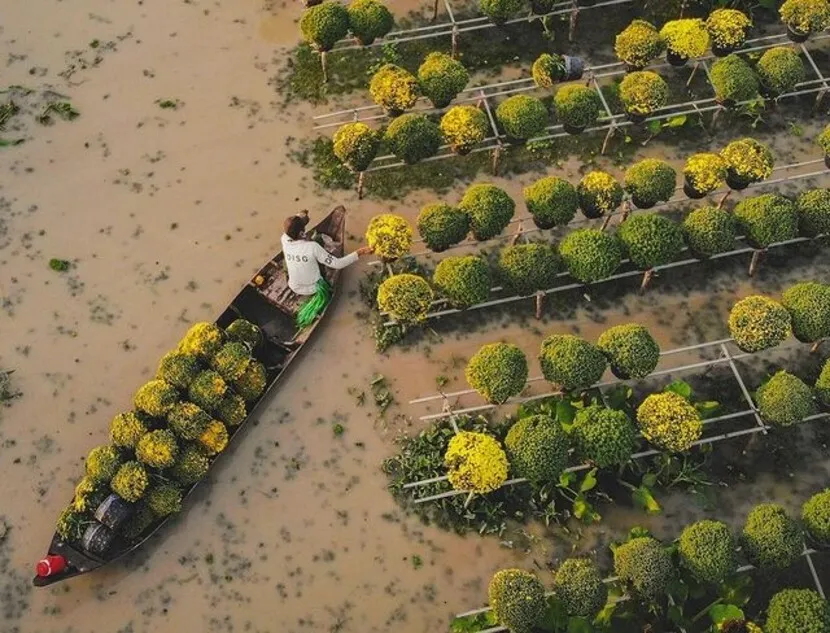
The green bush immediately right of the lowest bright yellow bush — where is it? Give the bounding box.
[504,414,569,485]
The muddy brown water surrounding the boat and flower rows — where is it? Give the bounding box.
[0,0,830,633]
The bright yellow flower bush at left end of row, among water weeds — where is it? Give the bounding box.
[444,431,507,494]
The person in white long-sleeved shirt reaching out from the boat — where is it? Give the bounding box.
[281,210,372,329]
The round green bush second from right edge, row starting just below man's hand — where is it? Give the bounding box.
[734,193,798,248]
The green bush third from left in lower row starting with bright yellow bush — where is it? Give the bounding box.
[571,405,637,468]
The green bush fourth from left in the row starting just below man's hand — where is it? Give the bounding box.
[559,229,623,284]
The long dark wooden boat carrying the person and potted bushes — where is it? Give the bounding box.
[33,207,346,587]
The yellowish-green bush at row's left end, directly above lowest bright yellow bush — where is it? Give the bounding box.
[464,343,528,404]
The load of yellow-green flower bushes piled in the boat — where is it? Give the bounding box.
[57,319,267,544]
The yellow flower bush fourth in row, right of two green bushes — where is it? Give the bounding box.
[637,391,703,453]
